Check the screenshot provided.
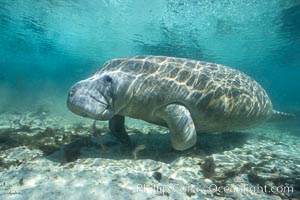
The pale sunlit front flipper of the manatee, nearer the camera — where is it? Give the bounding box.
[155,104,197,151]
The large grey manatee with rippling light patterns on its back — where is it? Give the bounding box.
[67,56,290,150]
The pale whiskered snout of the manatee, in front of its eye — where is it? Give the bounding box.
[67,80,111,120]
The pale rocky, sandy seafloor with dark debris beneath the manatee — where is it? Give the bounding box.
[0,111,300,199]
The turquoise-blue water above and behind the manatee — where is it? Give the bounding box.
[0,0,300,112]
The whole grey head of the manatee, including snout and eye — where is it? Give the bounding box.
[67,74,114,120]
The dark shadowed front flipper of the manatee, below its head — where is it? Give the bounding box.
[109,115,131,146]
